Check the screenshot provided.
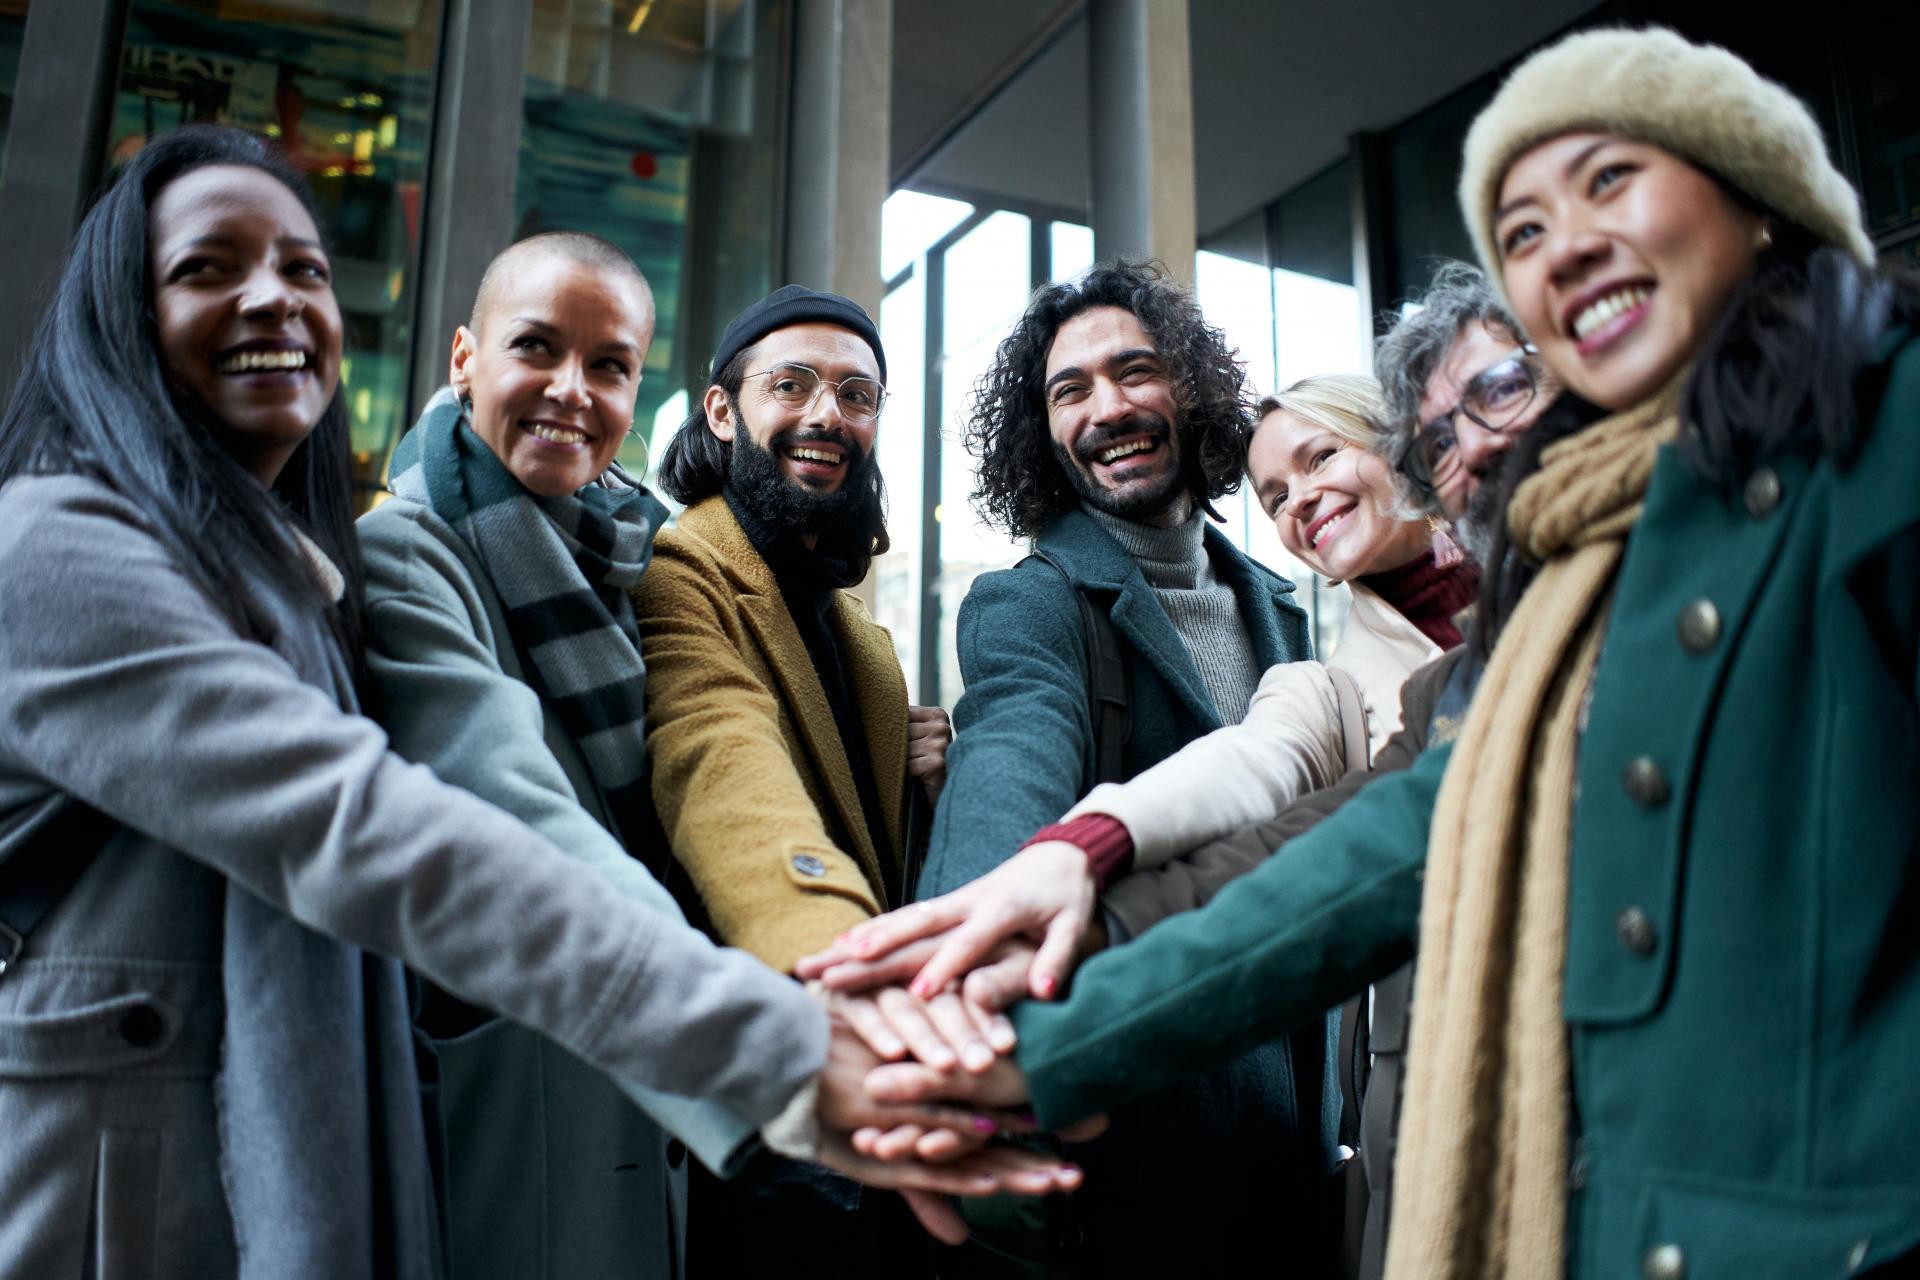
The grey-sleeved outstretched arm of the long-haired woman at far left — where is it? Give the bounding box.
[0,478,826,1123]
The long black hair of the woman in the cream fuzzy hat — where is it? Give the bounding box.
[1475,226,1920,656]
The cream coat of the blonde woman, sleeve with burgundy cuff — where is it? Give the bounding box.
[1068,583,1440,869]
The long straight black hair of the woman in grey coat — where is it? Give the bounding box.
[0,125,363,672]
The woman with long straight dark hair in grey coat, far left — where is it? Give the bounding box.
[0,129,1082,1280]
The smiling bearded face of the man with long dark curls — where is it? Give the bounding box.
[1043,307,1183,522]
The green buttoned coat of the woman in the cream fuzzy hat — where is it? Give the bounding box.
[1016,336,1920,1280]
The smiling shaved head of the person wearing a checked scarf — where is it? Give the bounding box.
[449,251,653,497]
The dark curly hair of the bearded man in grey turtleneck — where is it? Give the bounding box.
[964,259,1254,537]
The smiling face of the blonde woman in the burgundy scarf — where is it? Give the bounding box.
[1246,409,1432,581]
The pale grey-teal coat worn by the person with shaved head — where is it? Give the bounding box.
[359,497,756,1280]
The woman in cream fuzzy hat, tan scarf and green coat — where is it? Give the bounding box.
[856,31,1920,1280]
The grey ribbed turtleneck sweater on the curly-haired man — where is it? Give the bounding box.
[1083,507,1261,723]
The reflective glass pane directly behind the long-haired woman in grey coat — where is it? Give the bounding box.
[108,0,440,501]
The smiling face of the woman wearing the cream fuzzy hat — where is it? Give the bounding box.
[1494,132,1764,411]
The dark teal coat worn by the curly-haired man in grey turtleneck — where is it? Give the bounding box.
[920,510,1336,1276]
